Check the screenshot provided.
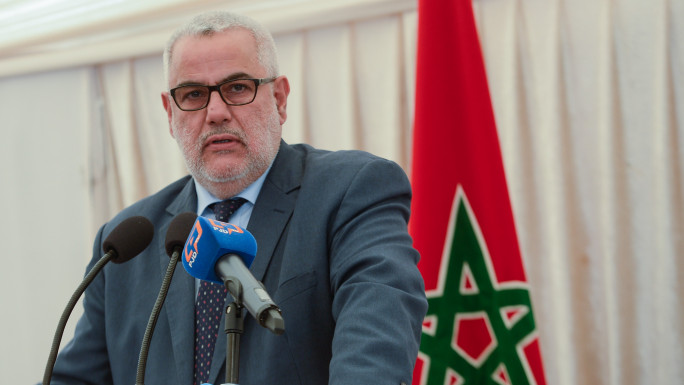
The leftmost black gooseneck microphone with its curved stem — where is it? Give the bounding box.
[43,216,154,385]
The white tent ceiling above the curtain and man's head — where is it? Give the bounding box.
[0,0,416,76]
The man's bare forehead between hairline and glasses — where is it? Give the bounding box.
[169,28,264,87]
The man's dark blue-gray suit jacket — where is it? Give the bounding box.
[52,142,427,385]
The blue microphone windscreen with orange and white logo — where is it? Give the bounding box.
[181,217,256,284]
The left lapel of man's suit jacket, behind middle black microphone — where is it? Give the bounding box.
[157,179,197,384]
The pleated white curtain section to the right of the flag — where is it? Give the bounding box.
[475,0,684,384]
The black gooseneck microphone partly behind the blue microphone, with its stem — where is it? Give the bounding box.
[135,212,197,385]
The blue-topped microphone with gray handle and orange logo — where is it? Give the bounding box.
[182,217,285,334]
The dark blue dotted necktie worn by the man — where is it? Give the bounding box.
[194,198,247,385]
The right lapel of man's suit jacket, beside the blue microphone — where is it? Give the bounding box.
[209,141,302,383]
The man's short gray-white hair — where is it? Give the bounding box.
[164,11,279,84]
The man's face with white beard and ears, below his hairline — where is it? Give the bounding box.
[162,29,289,194]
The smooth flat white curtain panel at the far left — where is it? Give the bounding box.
[0,68,96,376]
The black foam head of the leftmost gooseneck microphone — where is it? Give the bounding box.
[102,216,154,263]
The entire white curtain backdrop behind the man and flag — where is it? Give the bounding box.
[0,0,684,385]
